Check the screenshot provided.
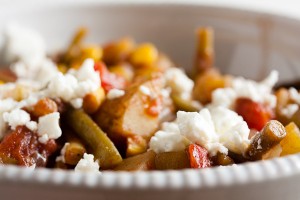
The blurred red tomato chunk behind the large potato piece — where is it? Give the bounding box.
[94,62,126,93]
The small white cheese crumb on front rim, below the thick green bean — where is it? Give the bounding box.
[75,153,100,173]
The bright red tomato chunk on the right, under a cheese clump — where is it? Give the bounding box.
[235,98,274,131]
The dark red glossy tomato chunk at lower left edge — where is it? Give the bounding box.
[0,126,57,167]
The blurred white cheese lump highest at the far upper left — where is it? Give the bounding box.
[3,24,46,66]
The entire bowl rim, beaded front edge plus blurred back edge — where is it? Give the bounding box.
[0,0,300,190]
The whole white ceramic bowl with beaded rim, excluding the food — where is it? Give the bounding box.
[0,0,300,200]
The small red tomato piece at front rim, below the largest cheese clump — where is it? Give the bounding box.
[187,144,212,169]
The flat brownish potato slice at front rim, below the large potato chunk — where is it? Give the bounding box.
[114,151,156,171]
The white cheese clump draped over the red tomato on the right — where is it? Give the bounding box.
[211,71,278,109]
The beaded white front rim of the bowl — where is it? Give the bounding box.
[0,154,300,190]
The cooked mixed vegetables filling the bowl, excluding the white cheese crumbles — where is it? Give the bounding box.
[0,28,300,171]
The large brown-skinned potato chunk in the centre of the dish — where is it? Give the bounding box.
[94,75,164,155]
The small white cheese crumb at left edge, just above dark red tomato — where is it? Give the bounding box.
[3,109,30,130]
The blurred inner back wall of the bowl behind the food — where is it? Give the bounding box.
[0,2,300,81]
